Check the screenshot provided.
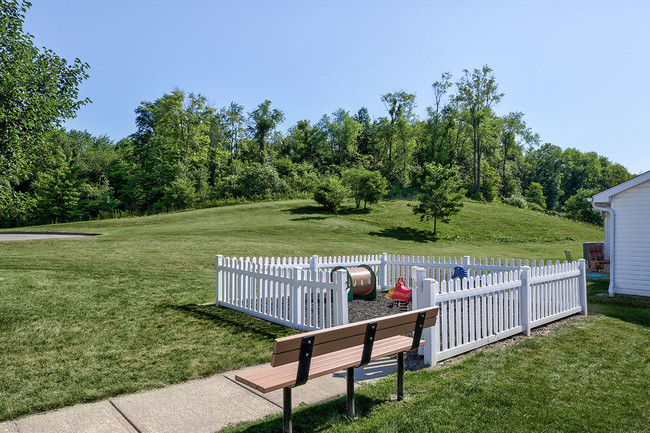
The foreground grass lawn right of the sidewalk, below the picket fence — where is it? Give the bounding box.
[228,281,650,433]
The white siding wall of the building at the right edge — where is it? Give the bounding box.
[612,181,650,296]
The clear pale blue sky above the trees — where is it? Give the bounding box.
[25,0,650,174]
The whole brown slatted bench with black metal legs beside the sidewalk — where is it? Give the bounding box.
[235,307,438,432]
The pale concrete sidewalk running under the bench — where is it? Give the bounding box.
[0,357,397,433]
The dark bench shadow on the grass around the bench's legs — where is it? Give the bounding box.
[221,390,385,433]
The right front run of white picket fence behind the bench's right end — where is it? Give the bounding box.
[412,260,587,365]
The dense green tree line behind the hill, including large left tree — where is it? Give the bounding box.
[0,0,630,227]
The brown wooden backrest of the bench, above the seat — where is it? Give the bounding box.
[271,307,438,367]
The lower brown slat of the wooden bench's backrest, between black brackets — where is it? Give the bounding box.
[271,316,436,367]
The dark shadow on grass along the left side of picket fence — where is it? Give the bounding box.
[163,304,296,340]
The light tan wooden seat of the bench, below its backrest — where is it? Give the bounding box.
[235,335,424,393]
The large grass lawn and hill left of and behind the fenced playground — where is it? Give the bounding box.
[0,200,602,420]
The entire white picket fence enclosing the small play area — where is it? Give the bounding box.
[216,253,587,364]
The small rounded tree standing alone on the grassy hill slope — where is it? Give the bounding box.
[413,164,466,235]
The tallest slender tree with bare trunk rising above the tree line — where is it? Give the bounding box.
[455,65,503,194]
